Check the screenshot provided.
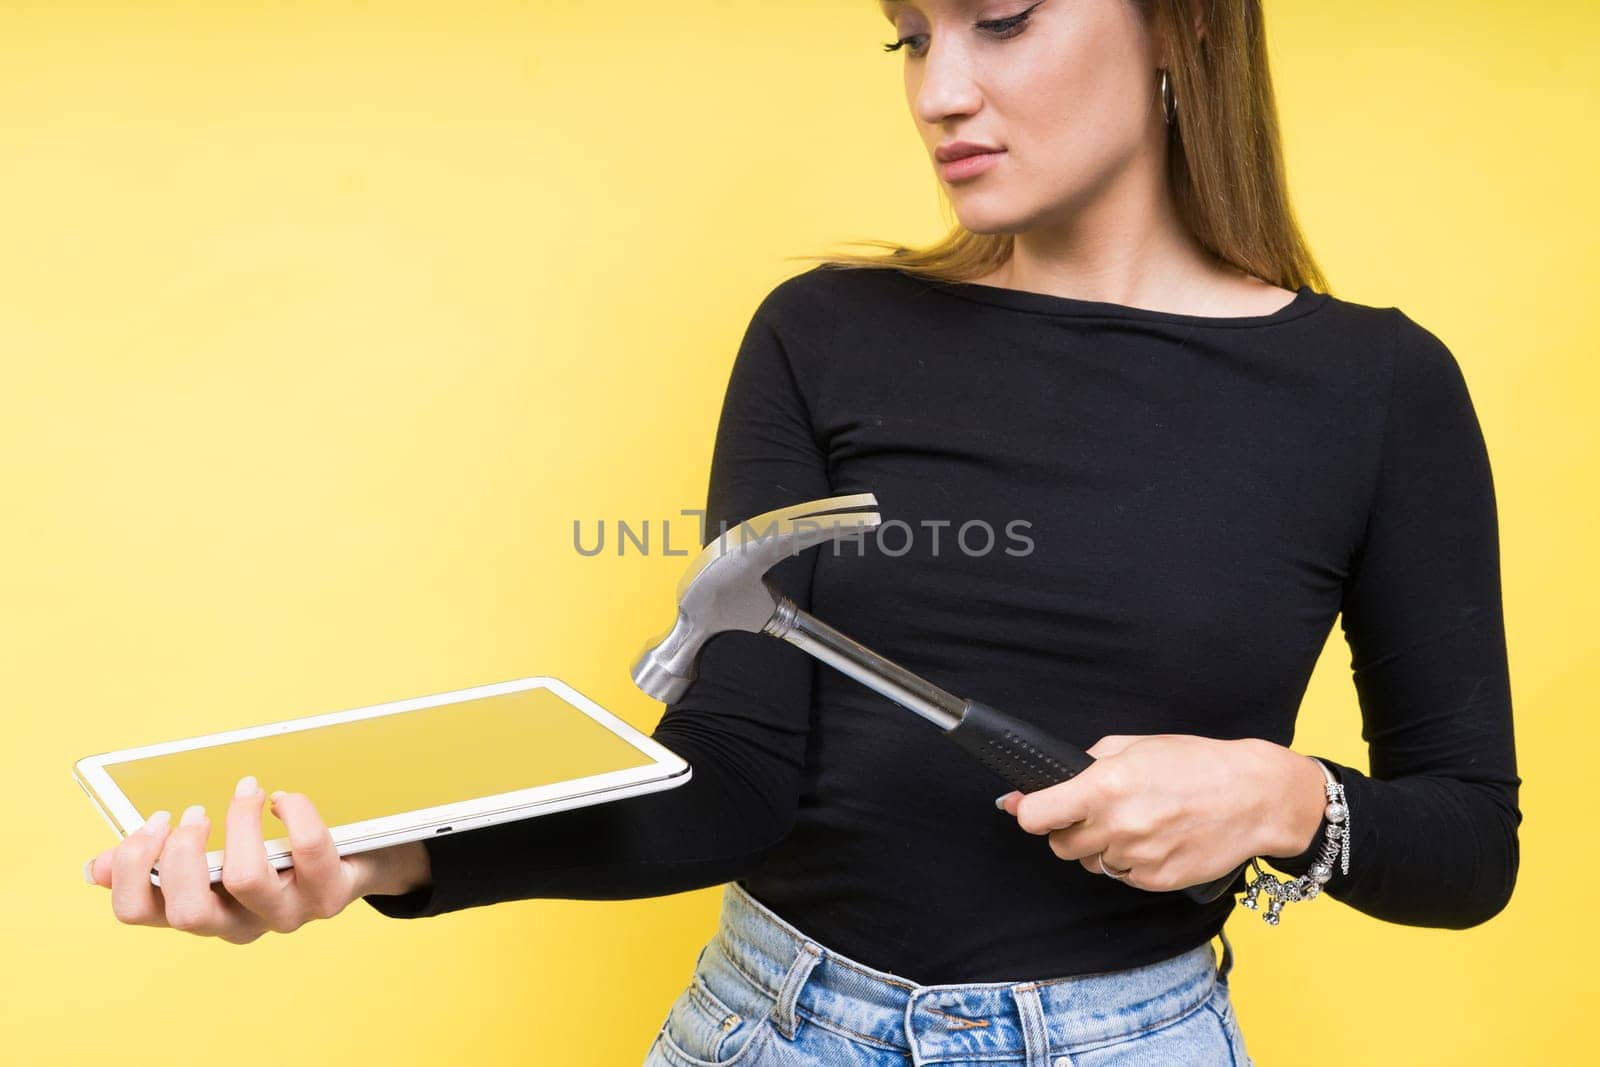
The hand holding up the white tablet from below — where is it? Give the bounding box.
[85,776,427,945]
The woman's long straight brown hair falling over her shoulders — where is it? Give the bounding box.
[786,0,1328,291]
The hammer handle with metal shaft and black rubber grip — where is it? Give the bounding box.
[763,597,1248,904]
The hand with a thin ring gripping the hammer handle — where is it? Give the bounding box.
[1003,734,1323,891]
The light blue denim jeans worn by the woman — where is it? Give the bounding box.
[645,883,1253,1067]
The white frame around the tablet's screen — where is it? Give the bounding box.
[72,675,693,886]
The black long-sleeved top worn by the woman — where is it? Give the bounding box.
[365,266,1522,984]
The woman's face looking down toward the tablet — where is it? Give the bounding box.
[878,0,1165,234]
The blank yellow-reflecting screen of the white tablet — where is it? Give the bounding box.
[104,688,653,851]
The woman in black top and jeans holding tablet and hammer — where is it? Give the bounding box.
[91,0,1522,1065]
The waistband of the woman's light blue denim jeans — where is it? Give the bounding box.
[702,883,1232,1064]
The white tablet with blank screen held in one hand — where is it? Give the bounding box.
[72,677,691,885]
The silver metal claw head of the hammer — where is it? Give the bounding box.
[632,493,878,704]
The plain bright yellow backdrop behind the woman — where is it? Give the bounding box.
[0,0,1600,1064]
